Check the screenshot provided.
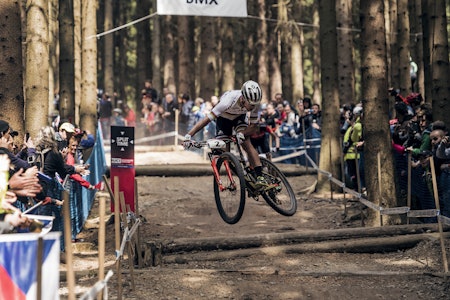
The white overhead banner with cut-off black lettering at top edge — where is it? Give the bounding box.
[157,0,247,17]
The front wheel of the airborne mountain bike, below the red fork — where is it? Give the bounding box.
[214,152,245,224]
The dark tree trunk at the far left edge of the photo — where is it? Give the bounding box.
[0,0,24,133]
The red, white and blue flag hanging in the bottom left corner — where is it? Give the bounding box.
[0,232,60,300]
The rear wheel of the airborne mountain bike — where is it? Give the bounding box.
[261,157,297,216]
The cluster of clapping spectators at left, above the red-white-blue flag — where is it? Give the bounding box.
[0,120,104,252]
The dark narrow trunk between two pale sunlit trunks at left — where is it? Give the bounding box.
[59,1,75,123]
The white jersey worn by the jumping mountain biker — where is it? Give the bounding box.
[209,90,259,123]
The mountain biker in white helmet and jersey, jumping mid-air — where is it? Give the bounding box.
[183,80,268,190]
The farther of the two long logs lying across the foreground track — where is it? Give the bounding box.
[162,224,446,254]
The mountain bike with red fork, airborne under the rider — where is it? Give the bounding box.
[191,136,297,224]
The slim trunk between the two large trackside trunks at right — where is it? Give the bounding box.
[336,0,357,104]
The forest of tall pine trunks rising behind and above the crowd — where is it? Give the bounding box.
[0,0,450,224]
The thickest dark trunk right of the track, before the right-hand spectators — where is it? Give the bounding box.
[360,0,399,226]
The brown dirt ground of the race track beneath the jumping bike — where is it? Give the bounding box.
[60,154,450,299]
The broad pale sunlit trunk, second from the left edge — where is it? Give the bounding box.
[25,0,49,136]
